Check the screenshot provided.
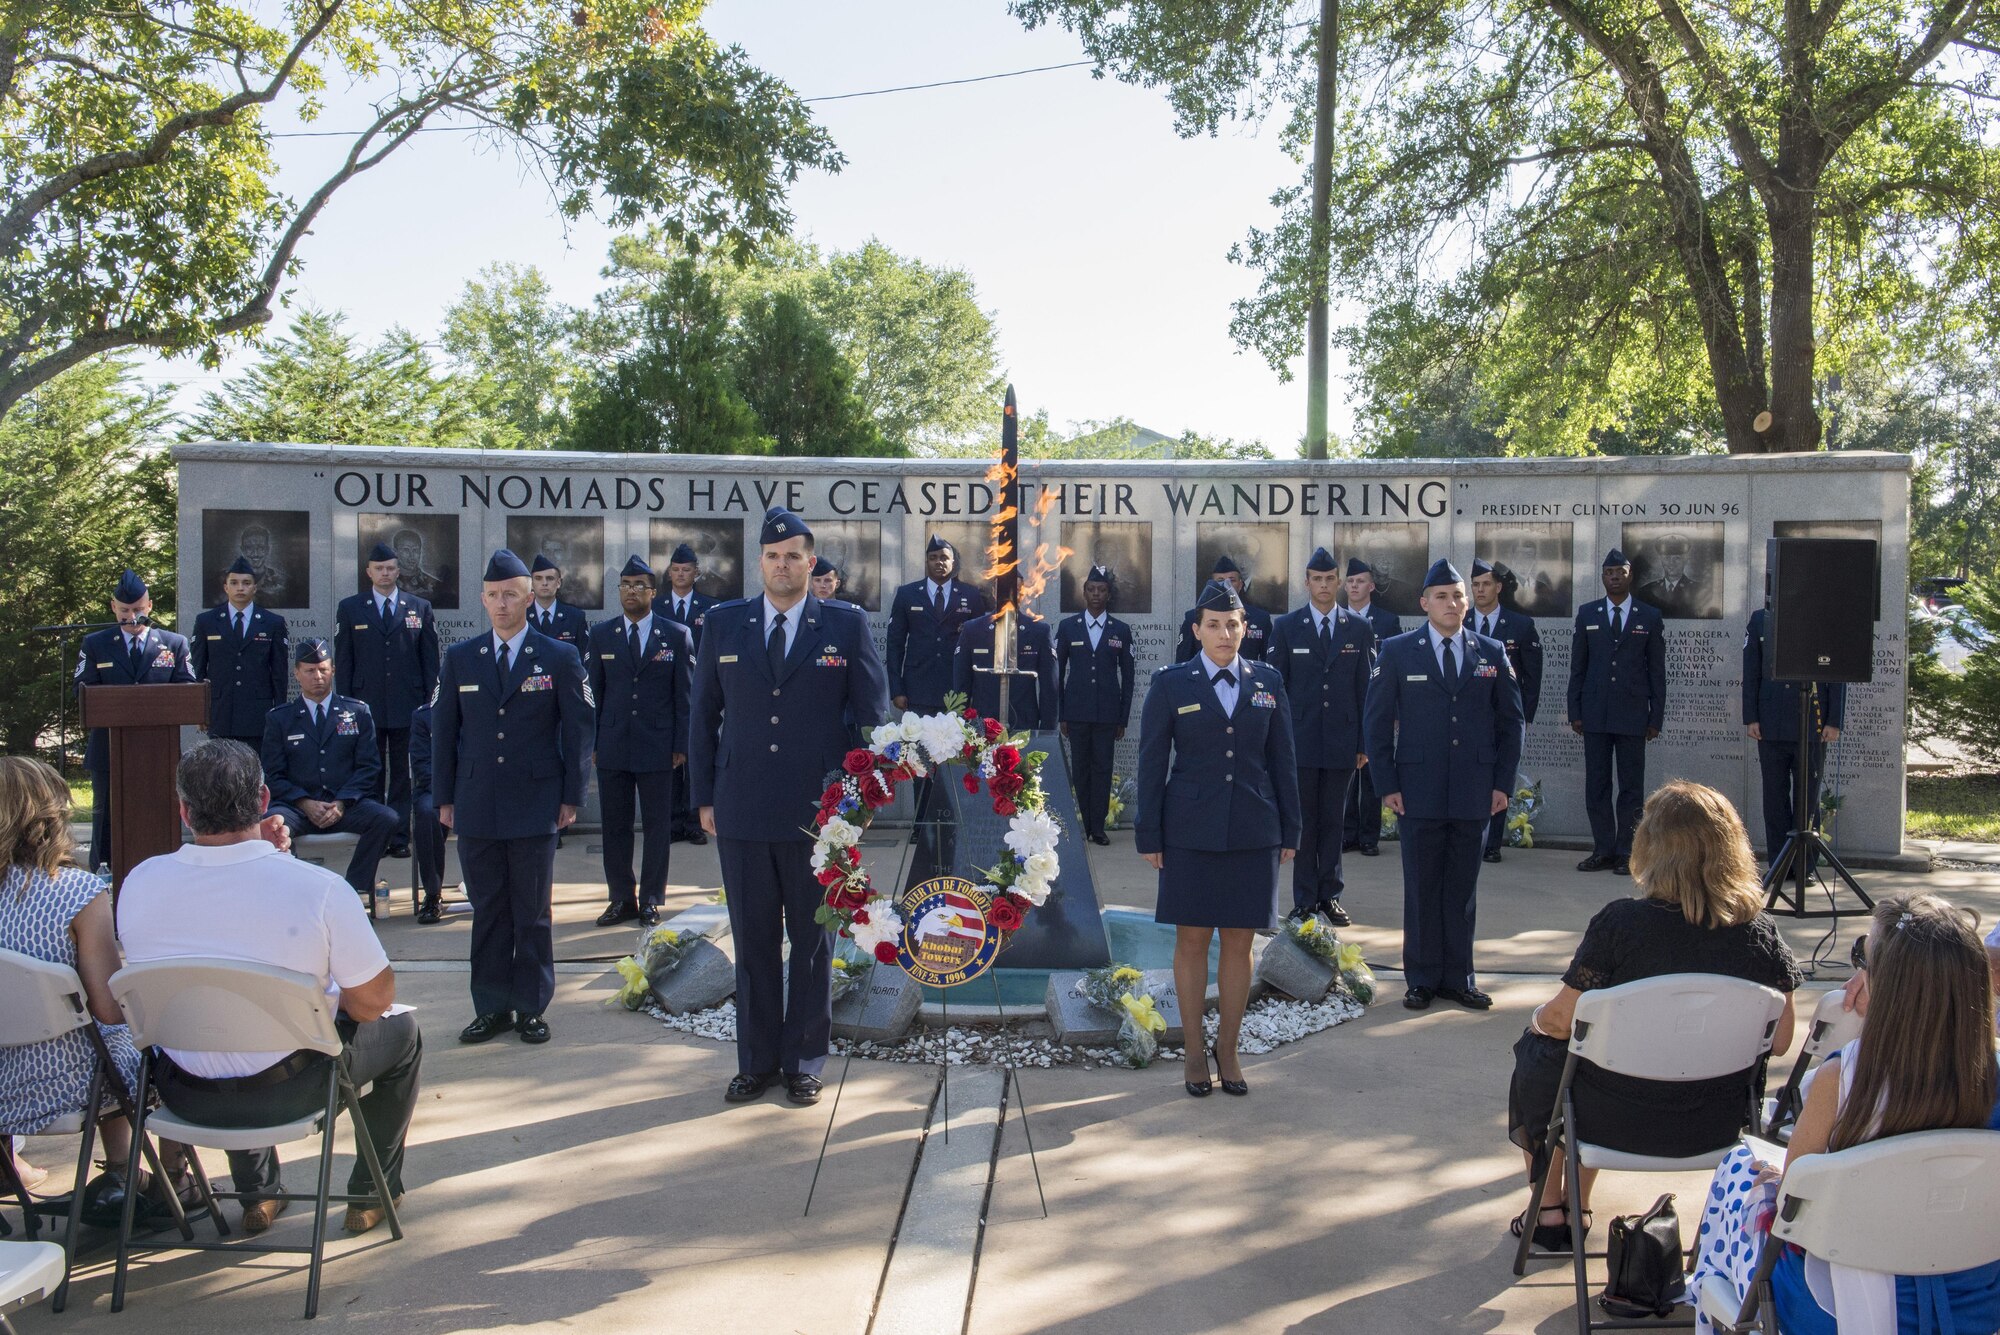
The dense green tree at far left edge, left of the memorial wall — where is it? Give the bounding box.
[0,360,176,753]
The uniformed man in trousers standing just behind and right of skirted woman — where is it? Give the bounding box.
[1264,548,1376,927]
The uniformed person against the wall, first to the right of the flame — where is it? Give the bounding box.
[1056,566,1134,843]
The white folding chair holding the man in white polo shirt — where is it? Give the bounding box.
[112,957,402,1321]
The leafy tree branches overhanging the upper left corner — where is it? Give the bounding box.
[0,0,840,414]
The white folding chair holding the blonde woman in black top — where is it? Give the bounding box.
[1514,973,1784,1335]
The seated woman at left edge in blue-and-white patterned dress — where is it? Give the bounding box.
[0,755,192,1221]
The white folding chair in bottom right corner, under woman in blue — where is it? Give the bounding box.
[1694,1131,2000,1335]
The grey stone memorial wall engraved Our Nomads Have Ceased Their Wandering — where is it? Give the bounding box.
[174,444,1910,855]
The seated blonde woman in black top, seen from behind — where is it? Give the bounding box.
[1508,779,1802,1251]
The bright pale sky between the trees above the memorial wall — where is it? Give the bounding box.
[148,0,1350,454]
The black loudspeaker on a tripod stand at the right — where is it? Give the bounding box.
[1764,538,1876,683]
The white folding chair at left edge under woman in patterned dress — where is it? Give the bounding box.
[0,949,209,1311]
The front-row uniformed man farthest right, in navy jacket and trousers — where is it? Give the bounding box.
[1364,562,1524,1011]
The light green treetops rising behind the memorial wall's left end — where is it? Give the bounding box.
[184,310,490,446]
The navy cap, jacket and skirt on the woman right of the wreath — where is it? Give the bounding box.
[1134,584,1300,929]
